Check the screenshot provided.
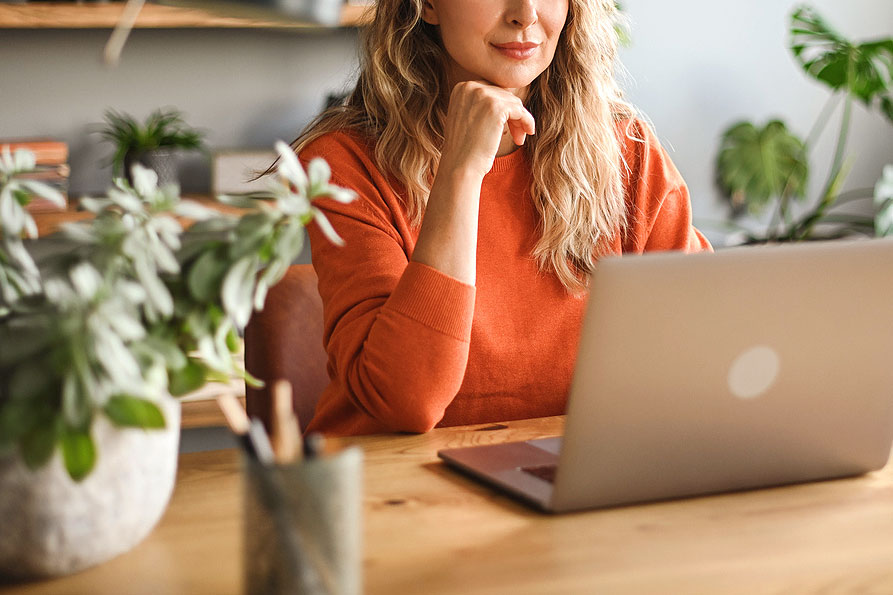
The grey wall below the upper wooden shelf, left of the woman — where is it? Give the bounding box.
[0,29,357,195]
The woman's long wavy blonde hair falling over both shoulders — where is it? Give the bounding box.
[292,0,635,293]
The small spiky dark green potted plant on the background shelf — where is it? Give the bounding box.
[99,108,204,186]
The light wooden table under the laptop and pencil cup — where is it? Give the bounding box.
[0,418,893,595]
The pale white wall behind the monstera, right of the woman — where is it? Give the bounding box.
[621,0,893,242]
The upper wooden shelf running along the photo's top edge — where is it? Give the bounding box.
[0,2,371,29]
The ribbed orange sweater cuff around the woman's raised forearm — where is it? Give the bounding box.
[385,262,475,342]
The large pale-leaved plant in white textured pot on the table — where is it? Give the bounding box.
[0,142,353,577]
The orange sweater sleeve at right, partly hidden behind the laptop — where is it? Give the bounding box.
[620,120,712,252]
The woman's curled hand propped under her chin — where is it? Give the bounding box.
[438,81,536,179]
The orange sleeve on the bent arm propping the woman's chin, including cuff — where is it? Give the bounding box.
[301,135,475,433]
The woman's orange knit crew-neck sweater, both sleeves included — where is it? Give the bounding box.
[301,124,710,435]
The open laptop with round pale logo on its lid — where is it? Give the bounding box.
[438,240,893,512]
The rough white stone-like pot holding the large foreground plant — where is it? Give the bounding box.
[0,397,180,579]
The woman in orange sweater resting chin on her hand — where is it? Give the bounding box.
[294,0,709,435]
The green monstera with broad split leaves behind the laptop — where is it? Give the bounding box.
[716,6,893,242]
